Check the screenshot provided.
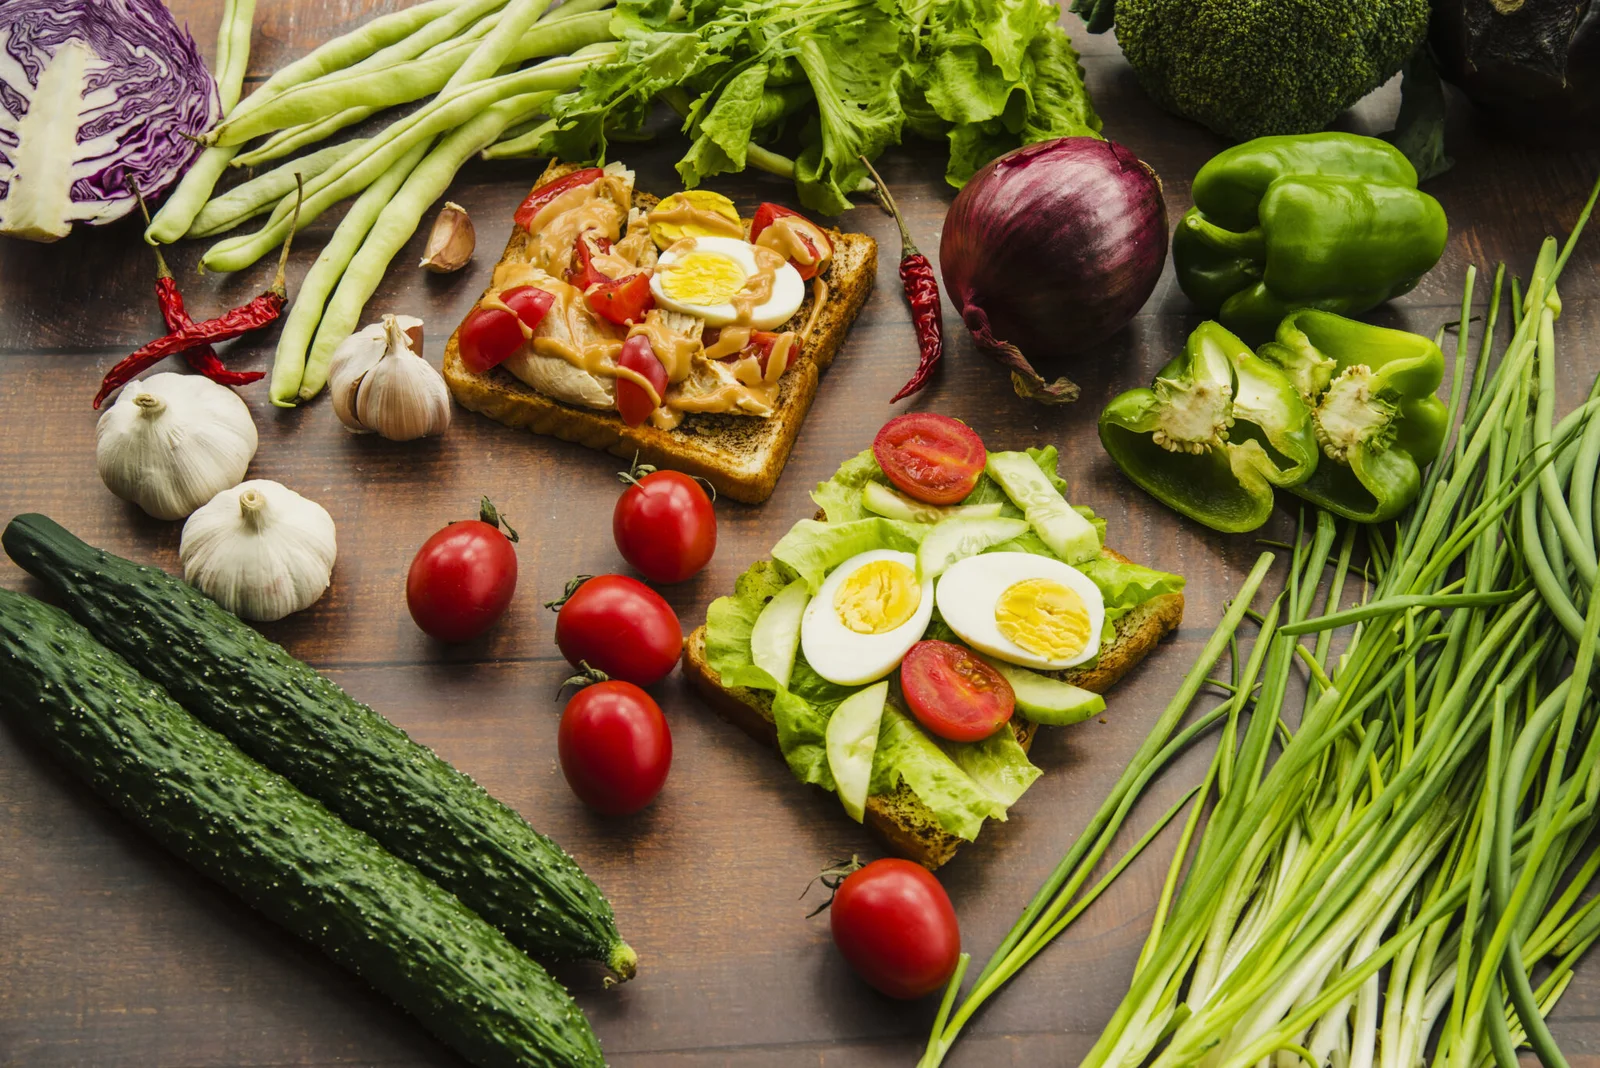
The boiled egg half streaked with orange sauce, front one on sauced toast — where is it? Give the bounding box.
[650,237,805,329]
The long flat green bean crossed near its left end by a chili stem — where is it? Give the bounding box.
[203,56,598,270]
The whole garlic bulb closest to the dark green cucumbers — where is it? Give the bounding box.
[178,478,338,622]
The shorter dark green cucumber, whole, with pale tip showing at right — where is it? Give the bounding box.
[0,515,637,978]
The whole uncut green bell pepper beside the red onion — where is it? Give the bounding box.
[1173,133,1448,342]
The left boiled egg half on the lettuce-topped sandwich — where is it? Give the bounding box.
[800,548,933,686]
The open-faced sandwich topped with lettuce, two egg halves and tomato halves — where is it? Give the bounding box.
[683,414,1184,868]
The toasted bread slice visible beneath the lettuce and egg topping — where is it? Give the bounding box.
[683,550,1184,871]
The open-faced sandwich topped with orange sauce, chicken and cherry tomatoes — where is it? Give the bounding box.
[445,163,877,502]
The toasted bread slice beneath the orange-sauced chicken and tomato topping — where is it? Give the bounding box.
[445,163,878,504]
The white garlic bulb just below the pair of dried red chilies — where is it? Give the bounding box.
[94,371,256,520]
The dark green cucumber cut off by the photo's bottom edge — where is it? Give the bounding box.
[0,590,605,1068]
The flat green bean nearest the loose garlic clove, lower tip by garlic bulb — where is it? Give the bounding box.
[299,93,554,400]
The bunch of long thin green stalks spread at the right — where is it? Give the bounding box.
[922,173,1600,1068]
